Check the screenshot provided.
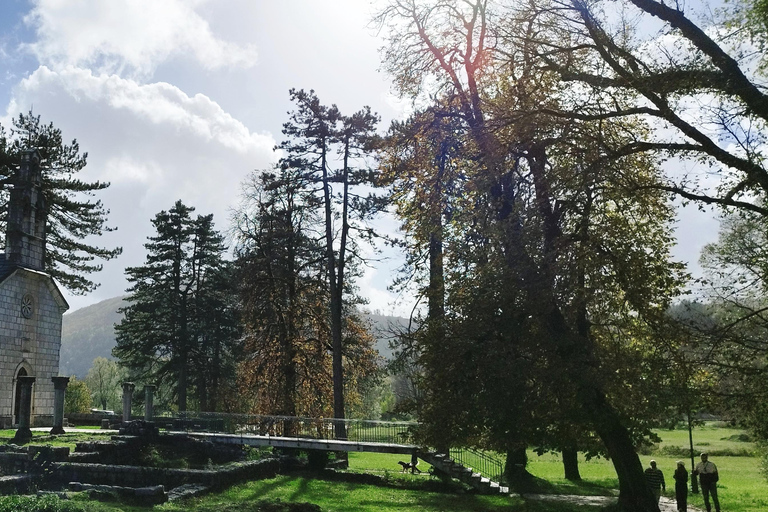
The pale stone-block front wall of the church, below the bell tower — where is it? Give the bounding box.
[0,269,63,426]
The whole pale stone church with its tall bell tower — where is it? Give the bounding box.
[0,150,69,428]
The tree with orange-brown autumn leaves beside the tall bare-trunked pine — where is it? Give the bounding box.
[235,165,378,417]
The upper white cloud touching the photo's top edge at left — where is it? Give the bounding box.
[25,0,257,77]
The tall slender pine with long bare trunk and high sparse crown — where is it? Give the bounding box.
[279,89,383,439]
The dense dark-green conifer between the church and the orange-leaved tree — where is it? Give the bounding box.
[113,201,237,412]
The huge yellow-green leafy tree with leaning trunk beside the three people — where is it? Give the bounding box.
[379,0,682,511]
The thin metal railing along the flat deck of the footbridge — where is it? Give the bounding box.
[158,412,418,445]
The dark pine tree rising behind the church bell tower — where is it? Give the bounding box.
[0,112,122,294]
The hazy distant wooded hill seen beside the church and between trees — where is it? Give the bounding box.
[59,297,408,378]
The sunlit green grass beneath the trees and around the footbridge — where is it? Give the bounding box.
[0,426,768,512]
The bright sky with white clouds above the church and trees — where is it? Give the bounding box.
[0,0,717,315]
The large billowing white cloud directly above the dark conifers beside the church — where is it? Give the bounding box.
[0,67,276,307]
